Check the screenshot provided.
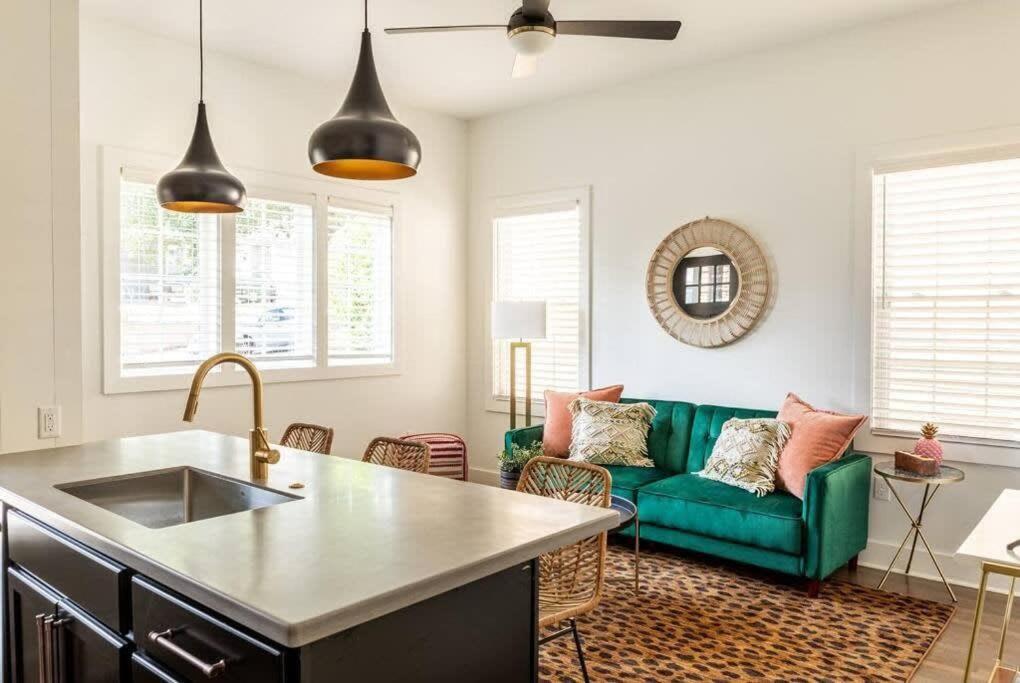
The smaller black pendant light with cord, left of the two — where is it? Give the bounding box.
[156,0,245,213]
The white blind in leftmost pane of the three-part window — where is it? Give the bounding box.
[119,176,220,376]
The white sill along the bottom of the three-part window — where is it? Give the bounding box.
[103,363,401,396]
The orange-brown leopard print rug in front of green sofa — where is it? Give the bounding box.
[540,544,956,683]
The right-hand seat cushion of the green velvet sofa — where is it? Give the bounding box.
[638,474,804,555]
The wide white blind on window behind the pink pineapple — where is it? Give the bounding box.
[872,159,1020,442]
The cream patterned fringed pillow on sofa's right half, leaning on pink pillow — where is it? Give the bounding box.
[698,418,791,496]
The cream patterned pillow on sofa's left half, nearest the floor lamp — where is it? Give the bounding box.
[569,397,655,467]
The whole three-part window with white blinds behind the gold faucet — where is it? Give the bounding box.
[102,149,399,393]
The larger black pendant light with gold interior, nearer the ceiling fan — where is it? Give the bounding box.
[308,0,421,180]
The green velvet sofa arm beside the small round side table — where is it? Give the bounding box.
[804,453,871,581]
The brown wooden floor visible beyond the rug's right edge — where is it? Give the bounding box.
[822,567,1020,683]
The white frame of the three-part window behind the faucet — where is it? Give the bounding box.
[99,147,405,395]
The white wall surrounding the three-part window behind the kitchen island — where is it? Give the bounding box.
[81,18,467,456]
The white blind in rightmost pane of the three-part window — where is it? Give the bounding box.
[326,199,394,365]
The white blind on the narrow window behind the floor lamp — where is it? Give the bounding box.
[492,202,587,399]
